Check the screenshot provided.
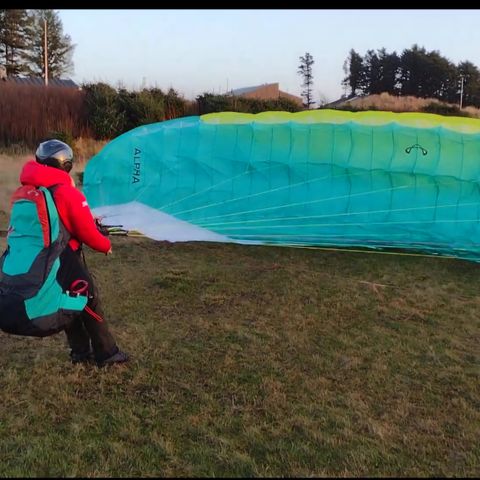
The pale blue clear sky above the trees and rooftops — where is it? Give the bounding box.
[57,9,480,103]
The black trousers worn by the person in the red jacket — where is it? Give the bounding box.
[57,247,118,362]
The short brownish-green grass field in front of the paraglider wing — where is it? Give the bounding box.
[0,155,480,477]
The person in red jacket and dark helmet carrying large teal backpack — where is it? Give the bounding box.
[0,139,129,367]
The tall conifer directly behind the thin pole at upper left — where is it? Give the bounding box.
[25,10,75,78]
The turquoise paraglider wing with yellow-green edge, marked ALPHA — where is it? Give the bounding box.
[84,110,480,260]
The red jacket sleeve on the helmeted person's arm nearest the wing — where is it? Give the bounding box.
[62,187,111,253]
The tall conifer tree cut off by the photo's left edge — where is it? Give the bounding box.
[0,9,31,75]
